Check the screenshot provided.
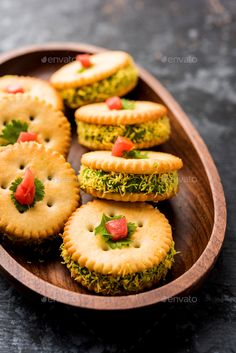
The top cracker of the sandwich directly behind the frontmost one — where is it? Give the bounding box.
[81,151,183,174]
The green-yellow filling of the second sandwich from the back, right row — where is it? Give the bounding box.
[77,116,170,149]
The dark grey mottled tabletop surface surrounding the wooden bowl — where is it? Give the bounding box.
[0,0,236,353]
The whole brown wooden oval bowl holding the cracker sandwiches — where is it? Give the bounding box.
[0,43,226,310]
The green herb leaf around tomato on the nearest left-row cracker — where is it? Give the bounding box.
[10,178,45,213]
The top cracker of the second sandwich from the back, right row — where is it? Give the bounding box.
[75,101,167,125]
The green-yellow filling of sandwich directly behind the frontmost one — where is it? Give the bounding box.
[79,165,178,195]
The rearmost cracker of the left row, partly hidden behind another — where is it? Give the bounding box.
[0,75,63,110]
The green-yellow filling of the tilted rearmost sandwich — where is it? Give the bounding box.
[59,65,137,108]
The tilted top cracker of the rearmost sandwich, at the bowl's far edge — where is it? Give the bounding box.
[50,51,133,89]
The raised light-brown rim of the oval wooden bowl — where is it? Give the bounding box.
[0,42,226,310]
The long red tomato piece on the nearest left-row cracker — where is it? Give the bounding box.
[14,168,35,206]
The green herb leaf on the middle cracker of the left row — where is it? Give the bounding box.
[0,120,28,146]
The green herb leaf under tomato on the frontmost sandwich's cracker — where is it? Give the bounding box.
[94,214,137,249]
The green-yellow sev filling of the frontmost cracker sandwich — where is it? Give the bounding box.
[61,242,176,295]
